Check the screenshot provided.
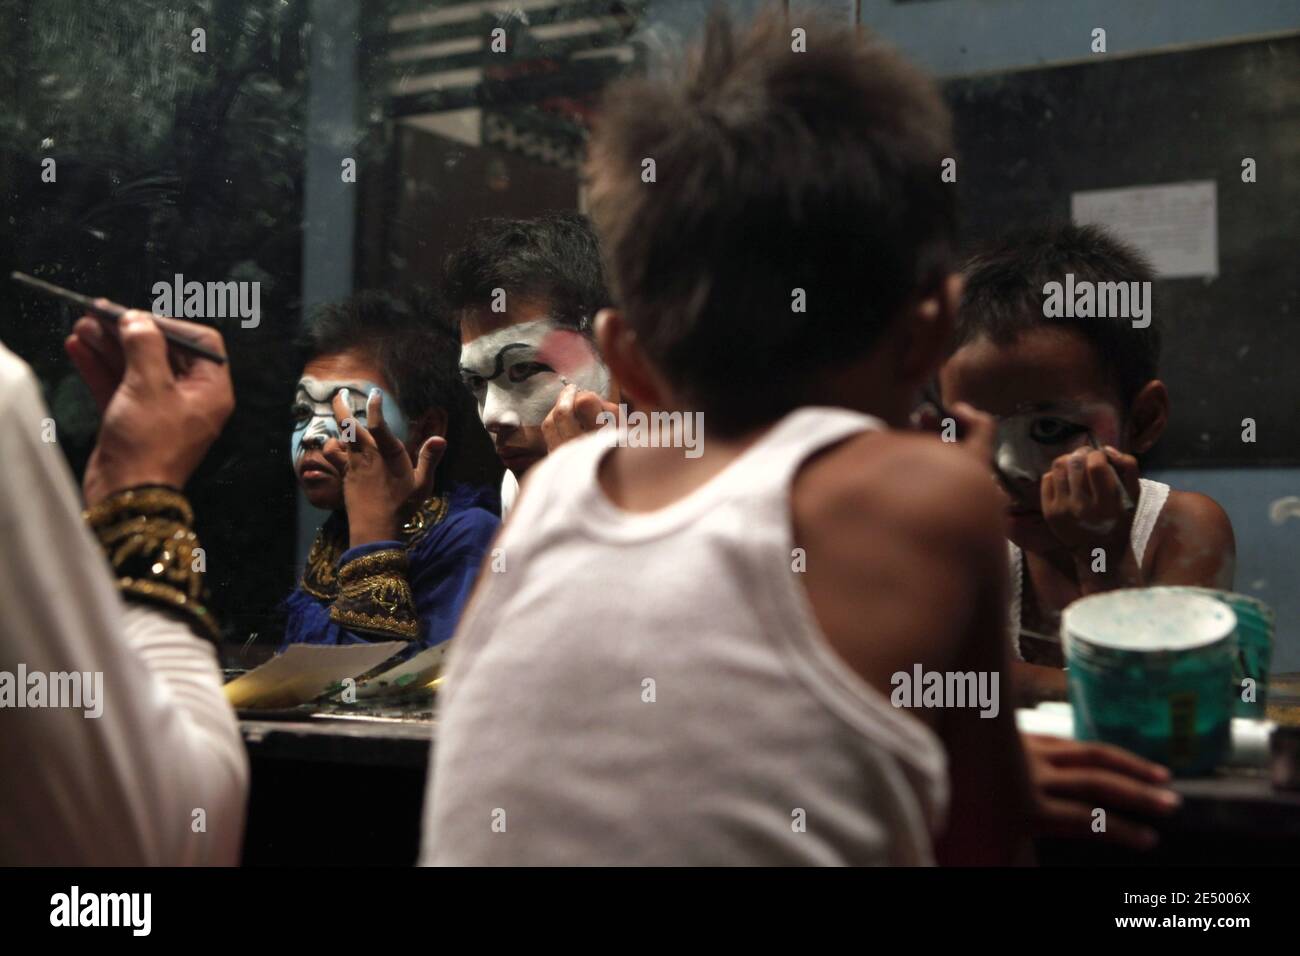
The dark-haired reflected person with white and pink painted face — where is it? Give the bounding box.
[443,213,618,515]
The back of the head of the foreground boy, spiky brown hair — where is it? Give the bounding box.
[590,6,956,434]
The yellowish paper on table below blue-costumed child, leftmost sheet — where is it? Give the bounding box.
[225,641,407,709]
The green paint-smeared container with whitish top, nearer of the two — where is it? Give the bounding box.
[1061,588,1236,777]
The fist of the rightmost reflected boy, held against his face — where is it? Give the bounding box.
[1040,445,1139,564]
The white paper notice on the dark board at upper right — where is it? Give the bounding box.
[1070,179,1218,278]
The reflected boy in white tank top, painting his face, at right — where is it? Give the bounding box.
[939,225,1235,696]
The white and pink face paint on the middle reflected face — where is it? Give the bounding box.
[460,319,610,428]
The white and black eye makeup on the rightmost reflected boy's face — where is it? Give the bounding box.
[993,405,1114,499]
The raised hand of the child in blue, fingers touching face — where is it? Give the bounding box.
[333,389,447,548]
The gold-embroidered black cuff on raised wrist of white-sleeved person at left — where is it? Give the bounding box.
[85,485,221,641]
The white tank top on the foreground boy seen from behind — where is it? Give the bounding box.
[423,408,948,865]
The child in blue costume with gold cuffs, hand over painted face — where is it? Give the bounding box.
[285,293,499,653]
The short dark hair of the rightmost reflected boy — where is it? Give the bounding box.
[952,222,1160,407]
